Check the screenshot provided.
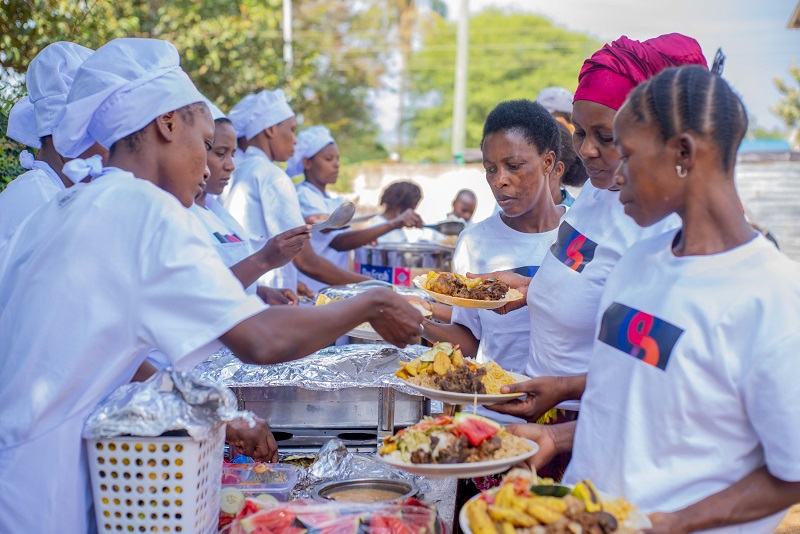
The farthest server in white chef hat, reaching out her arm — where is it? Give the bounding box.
[286,126,419,292]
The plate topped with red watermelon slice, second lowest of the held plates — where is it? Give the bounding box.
[378,412,539,478]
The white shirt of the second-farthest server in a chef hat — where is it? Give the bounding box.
[224,146,305,291]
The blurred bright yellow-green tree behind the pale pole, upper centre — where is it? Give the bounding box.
[403,9,602,161]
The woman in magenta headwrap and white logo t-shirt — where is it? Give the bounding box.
[493,34,706,432]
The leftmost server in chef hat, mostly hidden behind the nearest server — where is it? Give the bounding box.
[0,42,106,254]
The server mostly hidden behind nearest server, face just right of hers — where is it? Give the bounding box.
[189,100,308,305]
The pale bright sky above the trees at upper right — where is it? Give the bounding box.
[445,0,800,128]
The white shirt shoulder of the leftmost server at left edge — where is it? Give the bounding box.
[0,160,66,252]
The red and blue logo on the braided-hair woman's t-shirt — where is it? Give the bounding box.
[597,302,683,371]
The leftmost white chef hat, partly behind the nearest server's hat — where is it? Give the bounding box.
[8,42,93,148]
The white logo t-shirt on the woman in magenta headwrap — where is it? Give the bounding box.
[525,182,680,386]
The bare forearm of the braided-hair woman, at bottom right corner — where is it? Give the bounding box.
[644,467,800,534]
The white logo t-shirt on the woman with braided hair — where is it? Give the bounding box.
[564,232,800,534]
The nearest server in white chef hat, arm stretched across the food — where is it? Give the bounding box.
[0,39,421,533]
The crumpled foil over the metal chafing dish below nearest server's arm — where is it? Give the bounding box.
[197,344,427,395]
